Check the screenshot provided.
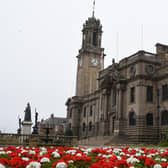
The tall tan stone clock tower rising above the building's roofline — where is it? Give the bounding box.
[76,15,104,96]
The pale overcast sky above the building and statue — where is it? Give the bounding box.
[0,0,168,132]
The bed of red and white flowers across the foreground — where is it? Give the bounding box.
[0,146,168,168]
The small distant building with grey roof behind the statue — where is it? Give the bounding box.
[39,114,66,136]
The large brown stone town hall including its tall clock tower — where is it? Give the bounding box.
[66,15,168,143]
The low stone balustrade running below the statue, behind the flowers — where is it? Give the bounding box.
[0,133,78,146]
